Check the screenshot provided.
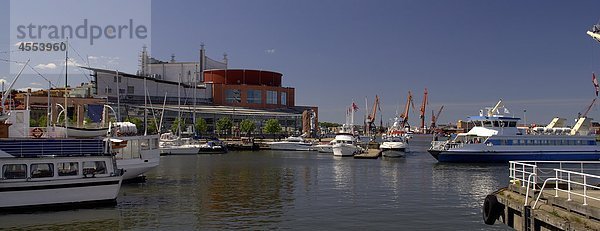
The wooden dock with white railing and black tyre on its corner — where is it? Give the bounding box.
[483,161,600,231]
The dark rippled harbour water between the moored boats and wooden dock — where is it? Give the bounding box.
[0,137,508,230]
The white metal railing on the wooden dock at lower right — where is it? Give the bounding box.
[509,161,600,208]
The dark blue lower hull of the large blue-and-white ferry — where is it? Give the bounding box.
[428,150,600,163]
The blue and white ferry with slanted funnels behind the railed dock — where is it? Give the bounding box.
[428,100,600,162]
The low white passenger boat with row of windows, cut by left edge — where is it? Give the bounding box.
[0,145,123,210]
